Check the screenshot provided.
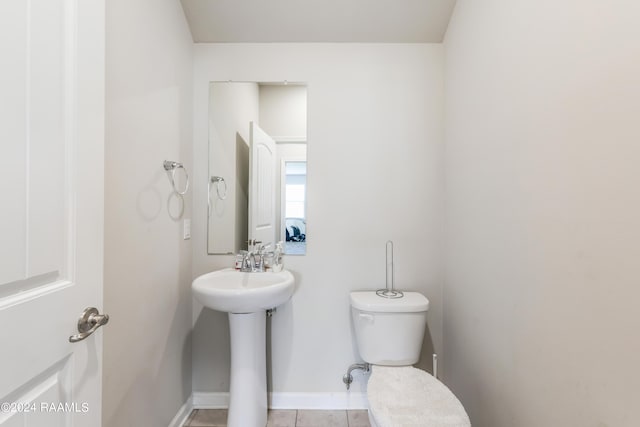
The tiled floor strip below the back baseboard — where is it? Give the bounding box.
[183,409,371,427]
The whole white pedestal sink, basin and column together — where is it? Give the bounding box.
[192,268,294,427]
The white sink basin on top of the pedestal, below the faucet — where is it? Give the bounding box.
[192,268,294,313]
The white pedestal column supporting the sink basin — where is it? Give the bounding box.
[227,311,267,427]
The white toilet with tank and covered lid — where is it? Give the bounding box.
[351,291,471,427]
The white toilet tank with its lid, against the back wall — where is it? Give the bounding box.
[350,291,429,366]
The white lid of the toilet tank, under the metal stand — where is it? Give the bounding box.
[350,291,429,313]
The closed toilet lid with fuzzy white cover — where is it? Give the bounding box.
[367,366,471,427]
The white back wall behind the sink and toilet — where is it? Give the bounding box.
[193,44,444,398]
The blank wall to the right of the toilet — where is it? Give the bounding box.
[444,0,640,427]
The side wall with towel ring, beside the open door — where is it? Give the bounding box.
[102,0,193,427]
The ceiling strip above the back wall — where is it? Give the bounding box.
[181,0,456,43]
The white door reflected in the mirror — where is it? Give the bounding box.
[249,122,276,244]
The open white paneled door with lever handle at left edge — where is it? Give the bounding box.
[0,0,105,427]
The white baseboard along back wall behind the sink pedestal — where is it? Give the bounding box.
[192,392,368,409]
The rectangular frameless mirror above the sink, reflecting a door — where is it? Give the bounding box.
[207,82,307,255]
